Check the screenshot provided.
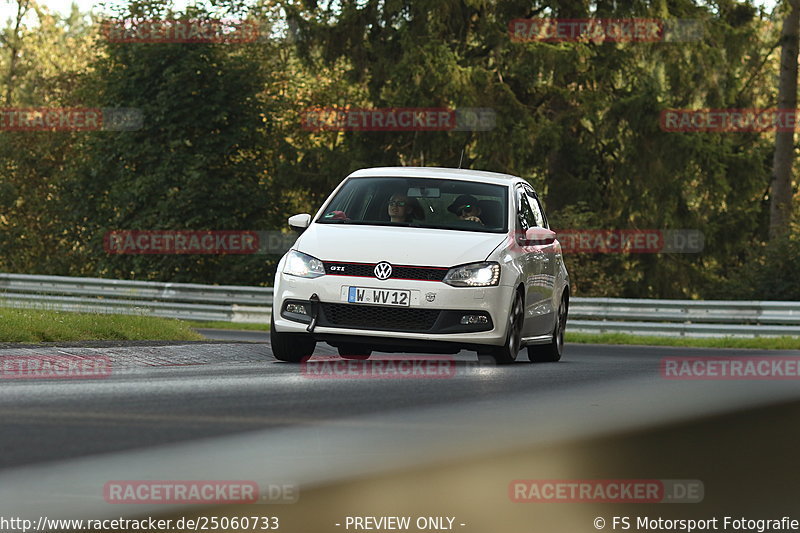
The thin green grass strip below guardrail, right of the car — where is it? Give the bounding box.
[566,332,800,350]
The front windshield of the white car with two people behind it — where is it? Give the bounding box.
[317,177,508,233]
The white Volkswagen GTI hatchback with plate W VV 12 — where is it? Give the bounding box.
[270,167,570,363]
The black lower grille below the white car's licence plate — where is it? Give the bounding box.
[319,303,441,332]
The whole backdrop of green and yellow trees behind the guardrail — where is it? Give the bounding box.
[0,0,800,299]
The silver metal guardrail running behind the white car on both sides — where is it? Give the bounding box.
[0,274,800,337]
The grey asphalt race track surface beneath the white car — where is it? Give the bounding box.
[0,332,788,468]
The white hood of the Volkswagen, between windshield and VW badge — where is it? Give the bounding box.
[293,223,506,267]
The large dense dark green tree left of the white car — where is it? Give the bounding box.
[59,0,280,283]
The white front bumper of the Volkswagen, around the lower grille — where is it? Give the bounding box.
[273,273,514,346]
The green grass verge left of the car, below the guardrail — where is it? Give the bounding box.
[0,307,203,342]
